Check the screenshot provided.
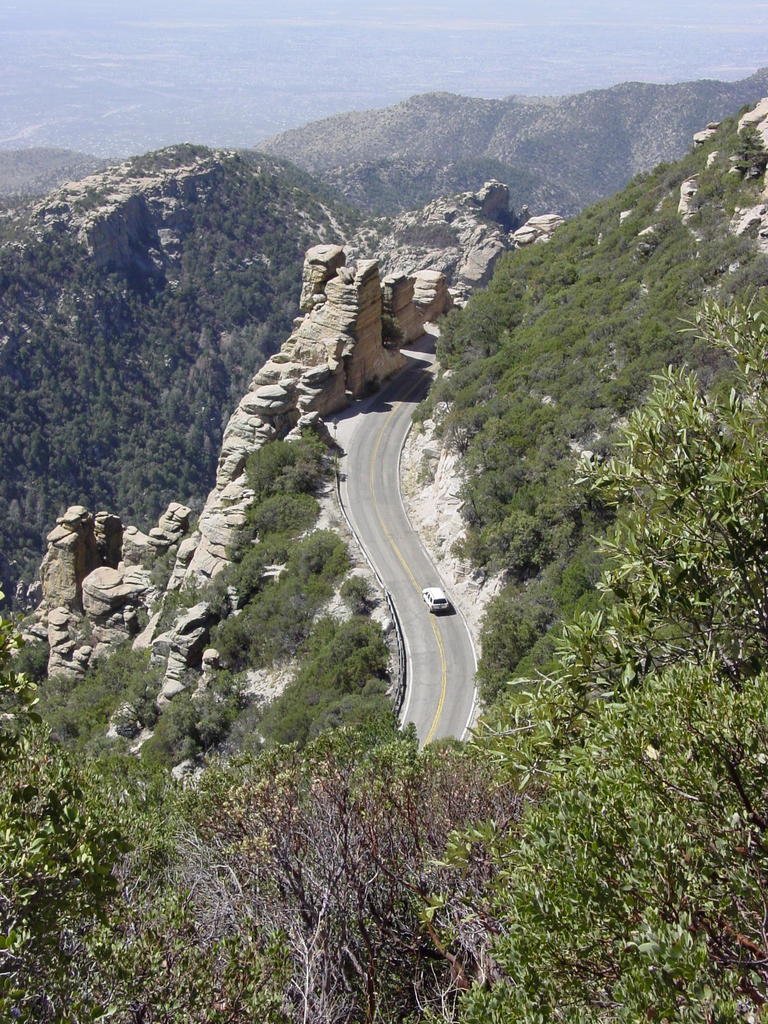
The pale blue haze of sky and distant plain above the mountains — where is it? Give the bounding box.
[0,0,768,154]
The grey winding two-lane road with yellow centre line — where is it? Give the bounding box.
[335,335,475,743]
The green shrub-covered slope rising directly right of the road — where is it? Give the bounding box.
[428,116,768,698]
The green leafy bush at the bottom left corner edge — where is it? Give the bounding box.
[0,598,128,1021]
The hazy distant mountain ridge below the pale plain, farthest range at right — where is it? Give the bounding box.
[260,68,768,214]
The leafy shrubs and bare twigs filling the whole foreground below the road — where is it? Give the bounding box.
[0,306,768,1024]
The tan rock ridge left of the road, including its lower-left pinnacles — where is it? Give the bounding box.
[27,245,451,707]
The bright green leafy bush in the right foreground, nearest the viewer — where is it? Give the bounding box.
[456,309,768,1022]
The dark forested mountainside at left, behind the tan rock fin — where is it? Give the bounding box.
[0,146,354,593]
